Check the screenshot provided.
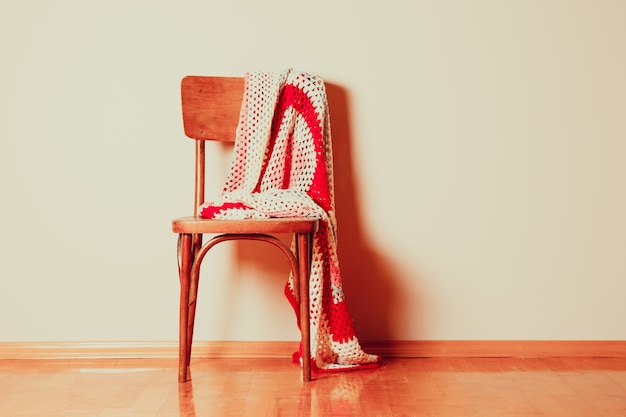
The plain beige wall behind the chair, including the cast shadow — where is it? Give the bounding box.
[0,0,626,342]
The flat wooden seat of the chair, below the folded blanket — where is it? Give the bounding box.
[172,216,319,234]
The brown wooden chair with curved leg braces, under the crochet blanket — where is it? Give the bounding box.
[172,76,318,382]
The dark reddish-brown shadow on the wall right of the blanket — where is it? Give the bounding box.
[326,82,417,341]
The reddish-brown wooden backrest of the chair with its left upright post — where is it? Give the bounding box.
[180,76,245,216]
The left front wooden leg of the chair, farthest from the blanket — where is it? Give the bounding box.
[178,234,193,382]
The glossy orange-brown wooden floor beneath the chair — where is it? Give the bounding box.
[0,358,626,417]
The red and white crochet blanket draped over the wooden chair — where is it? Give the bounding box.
[200,70,380,370]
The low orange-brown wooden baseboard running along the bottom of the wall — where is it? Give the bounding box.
[0,340,626,360]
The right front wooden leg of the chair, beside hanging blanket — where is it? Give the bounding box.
[297,233,311,382]
